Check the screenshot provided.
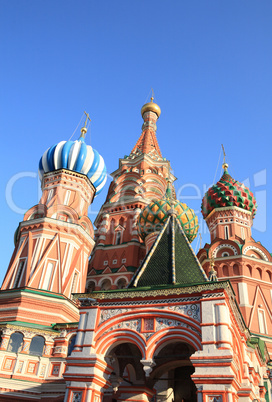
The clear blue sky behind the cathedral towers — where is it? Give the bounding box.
[0,0,272,279]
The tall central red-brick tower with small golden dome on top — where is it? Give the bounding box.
[87,98,175,290]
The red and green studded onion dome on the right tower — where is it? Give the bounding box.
[201,163,257,219]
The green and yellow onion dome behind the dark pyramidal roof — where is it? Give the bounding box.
[138,185,199,242]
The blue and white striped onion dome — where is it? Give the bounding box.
[39,136,107,195]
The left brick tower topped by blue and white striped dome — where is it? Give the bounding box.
[2,116,106,304]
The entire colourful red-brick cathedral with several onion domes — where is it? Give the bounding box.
[0,98,272,402]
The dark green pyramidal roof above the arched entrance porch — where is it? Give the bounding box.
[128,215,208,288]
